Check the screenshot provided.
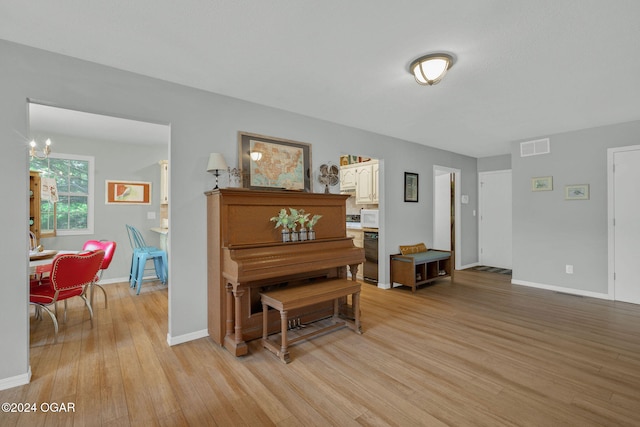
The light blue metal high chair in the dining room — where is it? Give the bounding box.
[127,225,168,295]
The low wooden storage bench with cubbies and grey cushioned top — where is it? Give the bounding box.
[390,249,453,292]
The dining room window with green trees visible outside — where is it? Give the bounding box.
[31,153,94,236]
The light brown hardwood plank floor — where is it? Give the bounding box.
[0,271,640,426]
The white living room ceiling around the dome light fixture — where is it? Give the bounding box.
[0,0,640,157]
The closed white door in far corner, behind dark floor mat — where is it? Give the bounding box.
[478,170,512,268]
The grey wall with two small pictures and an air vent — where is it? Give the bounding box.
[511,121,640,297]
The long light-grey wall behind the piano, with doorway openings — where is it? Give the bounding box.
[0,41,478,387]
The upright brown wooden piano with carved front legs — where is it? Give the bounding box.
[205,188,364,356]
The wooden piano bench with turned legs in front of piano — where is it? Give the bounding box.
[260,279,362,363]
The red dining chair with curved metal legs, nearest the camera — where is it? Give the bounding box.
[29,250,104,343]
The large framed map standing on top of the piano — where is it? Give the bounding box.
[238,132,312,192]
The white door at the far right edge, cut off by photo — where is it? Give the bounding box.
[613,149,640,304]
